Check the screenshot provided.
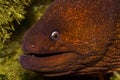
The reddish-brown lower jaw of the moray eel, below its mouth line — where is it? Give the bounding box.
[20,52,82,76]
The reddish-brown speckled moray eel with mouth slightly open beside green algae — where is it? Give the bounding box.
[20,0,120,76]
